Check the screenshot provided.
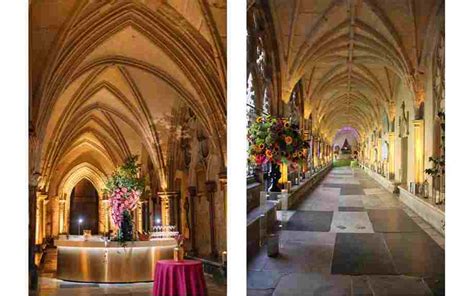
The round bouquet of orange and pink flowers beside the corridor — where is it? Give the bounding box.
[247,115,309,165]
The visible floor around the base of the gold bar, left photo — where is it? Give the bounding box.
[30,249,226,296]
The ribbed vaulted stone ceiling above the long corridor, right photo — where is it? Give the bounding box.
[269,0,443,138]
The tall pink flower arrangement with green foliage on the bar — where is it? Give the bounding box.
[104,156,145,242]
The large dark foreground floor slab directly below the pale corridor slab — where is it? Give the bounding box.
[332,233,396,275]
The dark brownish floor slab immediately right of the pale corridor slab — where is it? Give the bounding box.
[367,209,422,232]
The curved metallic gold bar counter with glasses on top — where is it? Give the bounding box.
[55,237,176,283]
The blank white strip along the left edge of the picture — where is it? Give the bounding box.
[0,1,28,295]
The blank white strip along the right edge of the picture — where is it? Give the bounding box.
[445,0,474,295]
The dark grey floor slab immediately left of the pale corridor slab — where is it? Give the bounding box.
[285,211,333,232]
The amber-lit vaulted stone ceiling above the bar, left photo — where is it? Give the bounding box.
[30,0,226,190]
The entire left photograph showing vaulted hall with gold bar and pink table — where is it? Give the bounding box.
[28,0,227,295]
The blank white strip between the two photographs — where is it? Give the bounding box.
[227,0,247,296]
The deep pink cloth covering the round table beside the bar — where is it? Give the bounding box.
[153,260,207,296]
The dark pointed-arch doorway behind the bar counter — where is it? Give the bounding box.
[69,179,99,235]
